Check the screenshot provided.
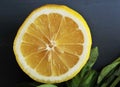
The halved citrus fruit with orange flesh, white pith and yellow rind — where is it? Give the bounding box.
[13,4,92,83]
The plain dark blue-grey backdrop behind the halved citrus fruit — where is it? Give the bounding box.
[0,0,120,87]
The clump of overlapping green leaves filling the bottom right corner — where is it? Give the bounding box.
[97,58,120,87]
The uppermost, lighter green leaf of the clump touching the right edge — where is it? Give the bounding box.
[97,58,120,84]
